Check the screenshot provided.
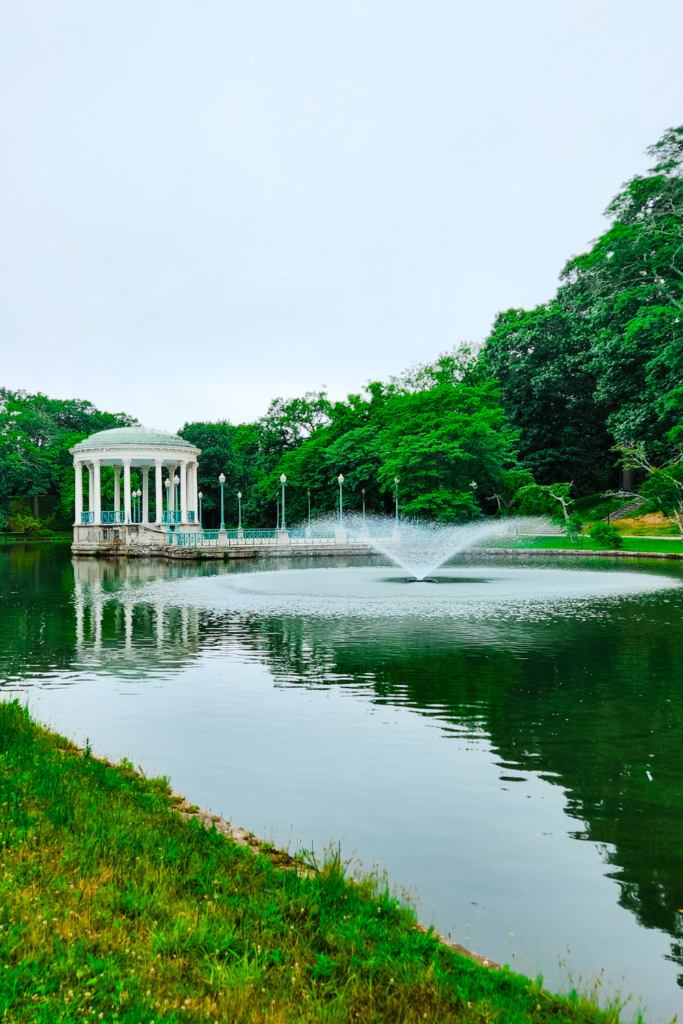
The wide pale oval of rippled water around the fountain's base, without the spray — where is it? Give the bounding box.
[121,566,681,620]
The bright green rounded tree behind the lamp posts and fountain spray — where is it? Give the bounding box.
[264,350,516,521]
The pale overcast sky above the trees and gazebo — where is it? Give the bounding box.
[0,0,683,429]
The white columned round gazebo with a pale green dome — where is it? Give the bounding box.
[70,427,201,545]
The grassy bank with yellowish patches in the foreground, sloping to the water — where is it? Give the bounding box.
[0,702,630,1024]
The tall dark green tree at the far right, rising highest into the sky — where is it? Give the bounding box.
[482,126,683,495]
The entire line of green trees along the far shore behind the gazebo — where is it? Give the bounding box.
[0,127,683,531]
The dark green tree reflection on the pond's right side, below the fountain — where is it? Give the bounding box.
[232,601,683,966]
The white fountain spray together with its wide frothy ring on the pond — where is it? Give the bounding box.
[125,517,678,620]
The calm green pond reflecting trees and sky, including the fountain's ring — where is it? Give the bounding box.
[0,544,683,1022]
